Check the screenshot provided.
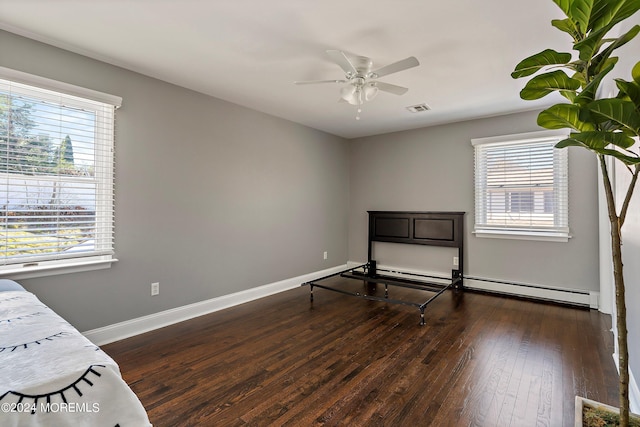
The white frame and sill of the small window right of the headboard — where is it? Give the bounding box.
[471,129,571,242]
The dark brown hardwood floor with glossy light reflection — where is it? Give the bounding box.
[103,279,617,427]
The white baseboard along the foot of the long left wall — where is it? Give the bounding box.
[82,265,346,345]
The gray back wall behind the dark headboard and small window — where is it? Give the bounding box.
[349,112,599,291]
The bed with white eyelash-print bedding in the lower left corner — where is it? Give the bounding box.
[0,280,151,427]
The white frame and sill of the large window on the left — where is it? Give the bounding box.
[0,67,122,279]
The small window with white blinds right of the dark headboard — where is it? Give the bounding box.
[471,131,569,241]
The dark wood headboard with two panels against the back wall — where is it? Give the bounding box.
[368,211,465,277]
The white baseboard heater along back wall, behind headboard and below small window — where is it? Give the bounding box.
[347,261,600,309]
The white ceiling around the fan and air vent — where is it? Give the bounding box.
[0,0,570,138]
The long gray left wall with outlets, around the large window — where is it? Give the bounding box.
[0,31,349,331]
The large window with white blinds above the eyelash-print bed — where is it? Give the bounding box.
[0,68,121,276]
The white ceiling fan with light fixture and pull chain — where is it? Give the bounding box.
[294,50,420,120]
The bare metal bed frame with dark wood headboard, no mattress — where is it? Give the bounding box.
[302,211,465,325]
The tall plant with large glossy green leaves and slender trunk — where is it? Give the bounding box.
[511,0,640,426]
